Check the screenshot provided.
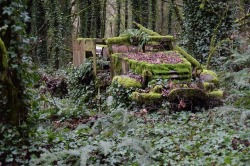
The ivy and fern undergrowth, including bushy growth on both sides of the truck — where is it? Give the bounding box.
[0,48,250,166]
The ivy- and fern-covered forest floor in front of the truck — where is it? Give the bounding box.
[25,71,250,166]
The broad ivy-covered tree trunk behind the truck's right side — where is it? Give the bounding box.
[183,0,233,63]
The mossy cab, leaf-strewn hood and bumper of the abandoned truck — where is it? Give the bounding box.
[75,23,223,109]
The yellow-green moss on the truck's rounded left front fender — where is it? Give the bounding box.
[112,76,142,88]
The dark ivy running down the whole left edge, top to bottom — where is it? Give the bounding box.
[0,0,36,165]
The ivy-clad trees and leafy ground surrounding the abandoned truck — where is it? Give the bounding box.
[0,0,250,165]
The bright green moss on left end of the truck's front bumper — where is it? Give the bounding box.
[132,92,162,103]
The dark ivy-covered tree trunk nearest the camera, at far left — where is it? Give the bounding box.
[0,0,29,124]
